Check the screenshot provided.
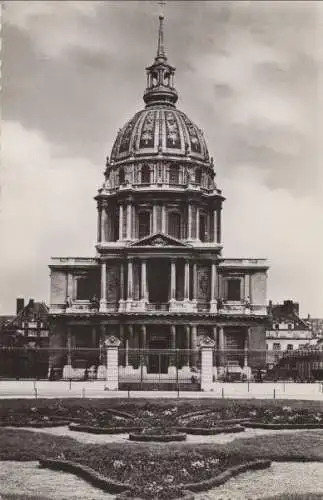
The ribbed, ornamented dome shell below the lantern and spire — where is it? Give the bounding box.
[111,104,209,163]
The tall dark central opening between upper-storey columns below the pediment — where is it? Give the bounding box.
[148,259,170,304]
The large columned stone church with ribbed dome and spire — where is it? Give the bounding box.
[50,16,268,383]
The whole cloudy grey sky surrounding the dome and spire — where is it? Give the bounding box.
[0,0,323,317]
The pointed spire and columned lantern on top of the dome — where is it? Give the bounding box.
[144,14,178,106]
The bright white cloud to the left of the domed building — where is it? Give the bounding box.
[0,122,103,311]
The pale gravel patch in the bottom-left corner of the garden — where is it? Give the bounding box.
[0,461,115,500]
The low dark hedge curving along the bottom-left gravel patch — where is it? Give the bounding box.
[39,458,131,493]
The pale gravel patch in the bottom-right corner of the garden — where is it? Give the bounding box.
[195,462,323,500]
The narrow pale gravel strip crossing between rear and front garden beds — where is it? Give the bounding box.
[7,426,323,446]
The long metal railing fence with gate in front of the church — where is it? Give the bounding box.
[0,345,323,384]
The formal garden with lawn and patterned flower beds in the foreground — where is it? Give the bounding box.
[0,399,323,500]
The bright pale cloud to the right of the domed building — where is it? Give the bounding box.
[222,165,323,316]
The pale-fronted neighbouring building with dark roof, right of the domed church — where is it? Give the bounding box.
[266,300,317,368]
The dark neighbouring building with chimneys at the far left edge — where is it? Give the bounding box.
[0,298,49,378]
